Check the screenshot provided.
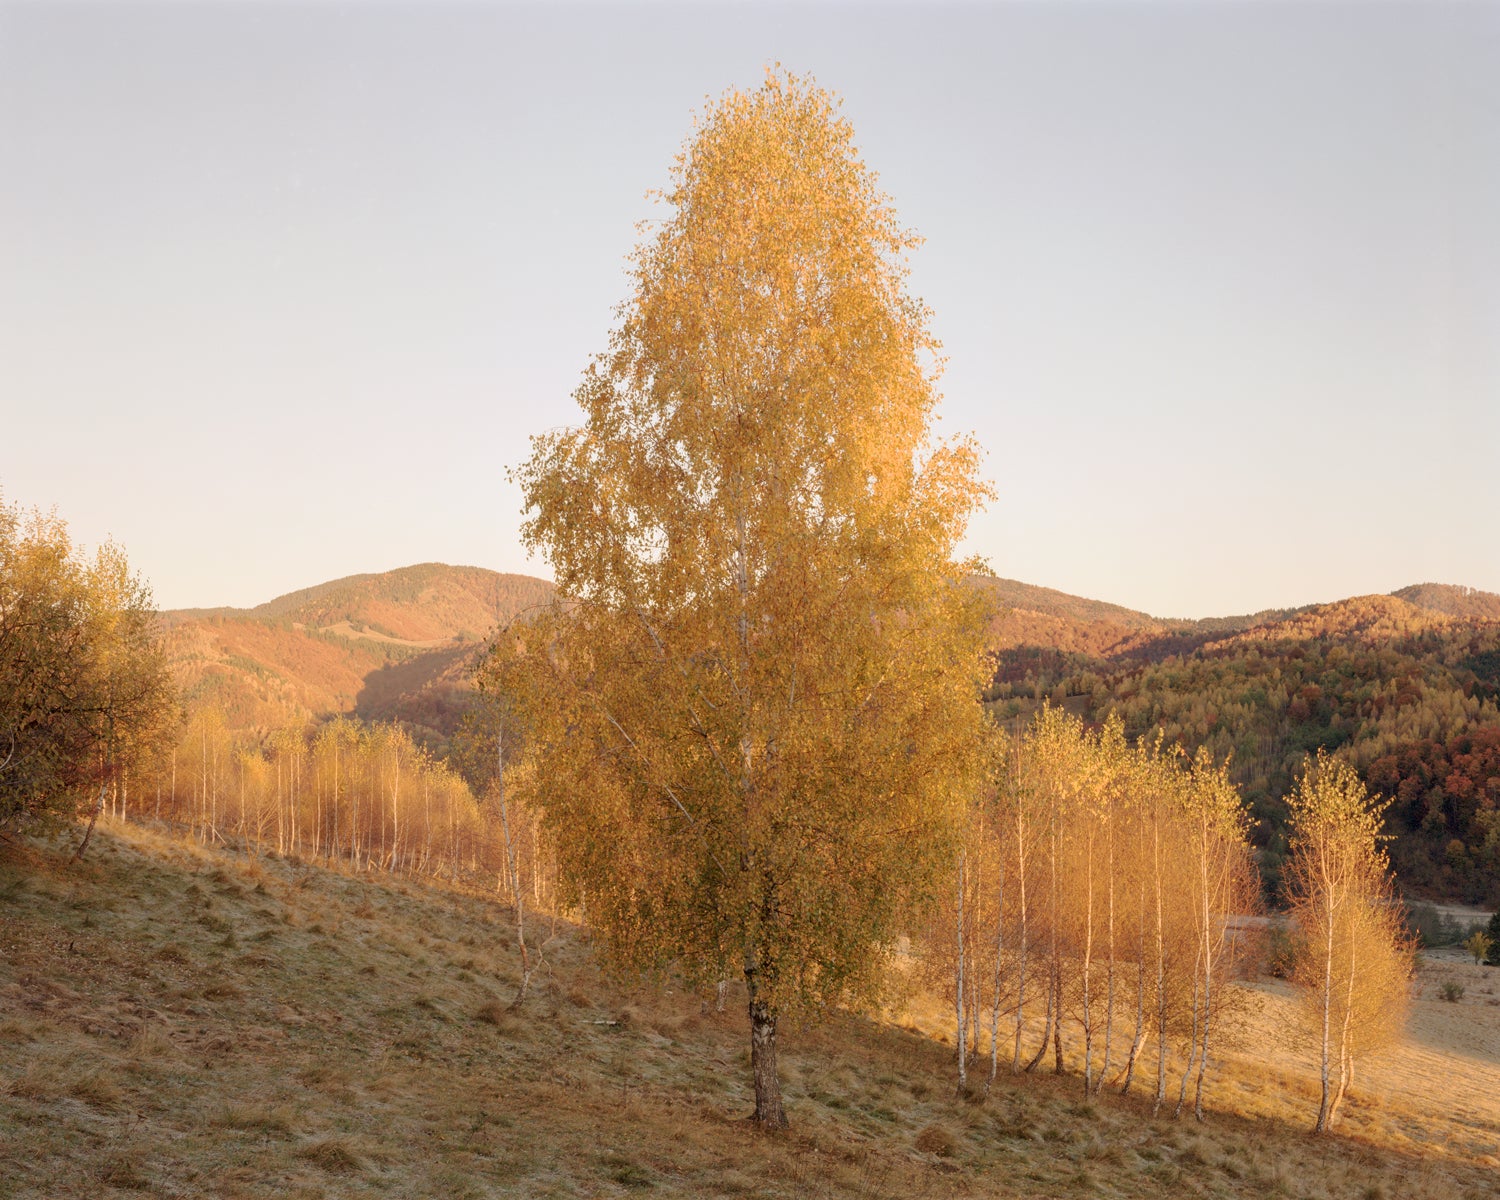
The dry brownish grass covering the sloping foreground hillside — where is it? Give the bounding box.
[0,830,1500,1200]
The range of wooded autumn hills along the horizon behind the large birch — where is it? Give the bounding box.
[165,564,1500,906]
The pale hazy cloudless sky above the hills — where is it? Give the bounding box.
[0,0,1500,617]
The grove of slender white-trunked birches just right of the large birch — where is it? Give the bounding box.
[929,707,1260,1119]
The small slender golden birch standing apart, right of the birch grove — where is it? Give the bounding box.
[1286,752,1412,1133]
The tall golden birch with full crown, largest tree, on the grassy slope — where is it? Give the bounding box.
[491,77,986,1128]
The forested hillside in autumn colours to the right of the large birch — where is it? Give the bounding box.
[990,584,1500,905]
